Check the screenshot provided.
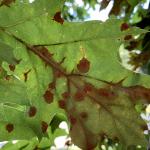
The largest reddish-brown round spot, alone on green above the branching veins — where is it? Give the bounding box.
[77,57,90,73]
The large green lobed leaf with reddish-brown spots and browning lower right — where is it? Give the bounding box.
[0,0,150,150]
